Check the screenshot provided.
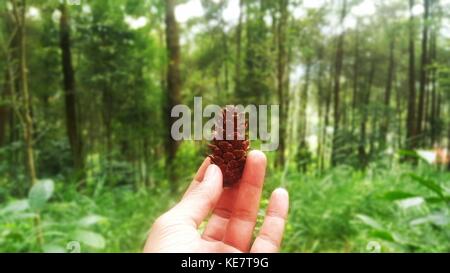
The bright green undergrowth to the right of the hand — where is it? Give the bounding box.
[278,163,450,252]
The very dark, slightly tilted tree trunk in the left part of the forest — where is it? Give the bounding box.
[60,3,83,172]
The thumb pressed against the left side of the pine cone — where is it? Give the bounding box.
[174,164,223,227]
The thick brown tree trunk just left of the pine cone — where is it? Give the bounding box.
[164,0,181,191]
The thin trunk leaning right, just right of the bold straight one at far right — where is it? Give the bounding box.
[416,0,429,145]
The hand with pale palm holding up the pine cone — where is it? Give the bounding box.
[144,151,289,253]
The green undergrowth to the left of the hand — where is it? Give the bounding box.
[0,182,170,252]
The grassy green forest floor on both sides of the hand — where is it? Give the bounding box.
[0,162,450,252]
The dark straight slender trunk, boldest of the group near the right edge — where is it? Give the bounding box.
[406,0,417,149]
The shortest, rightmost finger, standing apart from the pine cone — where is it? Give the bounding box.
[251,189,289,253]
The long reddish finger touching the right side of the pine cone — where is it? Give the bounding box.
[223,151,266,252]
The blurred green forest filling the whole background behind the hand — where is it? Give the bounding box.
[0,0,450,252]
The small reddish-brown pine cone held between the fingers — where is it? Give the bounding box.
[209,106,249,187]
